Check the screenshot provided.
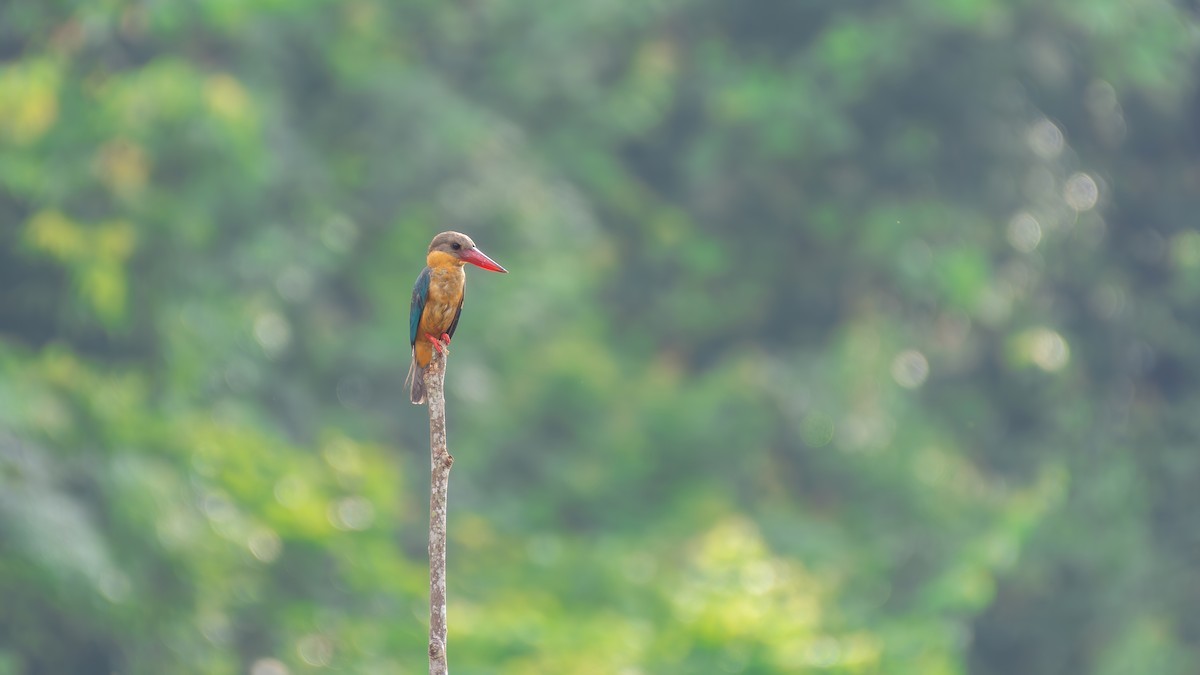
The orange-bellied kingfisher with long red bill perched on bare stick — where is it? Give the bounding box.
[408,232,509,405]
